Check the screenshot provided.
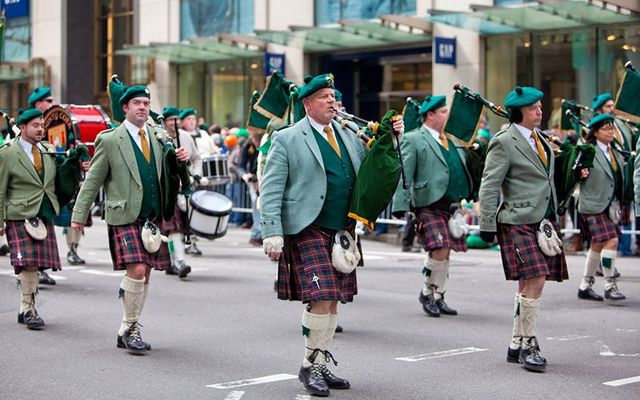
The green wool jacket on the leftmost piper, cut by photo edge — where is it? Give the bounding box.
[0,139,60,223]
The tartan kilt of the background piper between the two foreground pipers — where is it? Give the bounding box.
[416,207,467,252]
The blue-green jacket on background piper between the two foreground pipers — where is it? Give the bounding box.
[393,125,473,212]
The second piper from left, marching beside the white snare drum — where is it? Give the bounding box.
[71,86,189,354]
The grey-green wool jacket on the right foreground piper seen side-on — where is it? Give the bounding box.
[479,124,558,232]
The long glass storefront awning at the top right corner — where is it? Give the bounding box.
[426,0,640,36]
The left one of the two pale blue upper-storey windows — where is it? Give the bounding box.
[180,0,254,40]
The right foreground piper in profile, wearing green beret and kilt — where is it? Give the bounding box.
[480,87,588,371]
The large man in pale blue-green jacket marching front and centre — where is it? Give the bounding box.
[260,74,366,396]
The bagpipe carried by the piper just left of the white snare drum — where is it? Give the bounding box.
[107,74,191,221]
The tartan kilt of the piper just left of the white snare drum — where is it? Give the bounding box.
[108,218,171,271]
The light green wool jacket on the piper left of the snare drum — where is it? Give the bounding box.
[71,124,166,225]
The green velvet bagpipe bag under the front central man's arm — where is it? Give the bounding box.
[349,110,400,229]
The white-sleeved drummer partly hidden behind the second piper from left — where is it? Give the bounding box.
[162,107,202,278]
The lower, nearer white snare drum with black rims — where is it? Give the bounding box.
[189,190,233,239]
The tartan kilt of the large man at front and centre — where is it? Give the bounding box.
[278,225,362,303]
